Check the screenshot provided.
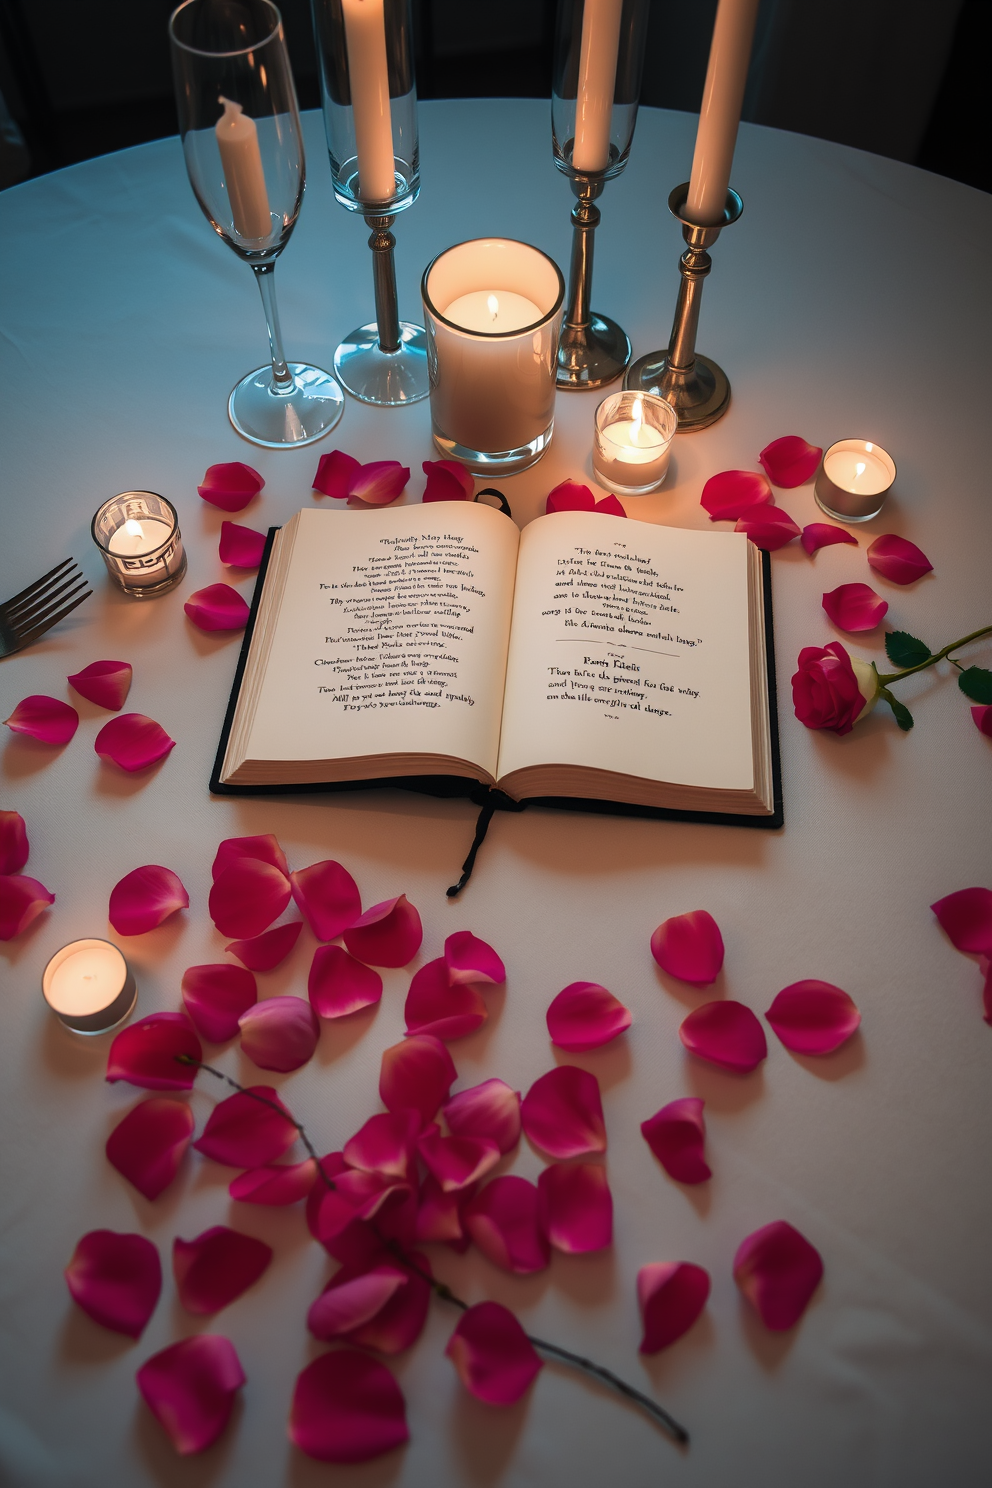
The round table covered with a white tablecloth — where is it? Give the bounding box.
[0,100,992,1488]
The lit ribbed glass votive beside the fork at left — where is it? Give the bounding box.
[92,491,186,600]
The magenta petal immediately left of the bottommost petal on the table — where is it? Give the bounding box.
[135,1333,245,1457]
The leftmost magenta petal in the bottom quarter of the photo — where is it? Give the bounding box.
[65,1229,162,1338]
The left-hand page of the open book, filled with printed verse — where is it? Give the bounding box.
[244,501,519,774]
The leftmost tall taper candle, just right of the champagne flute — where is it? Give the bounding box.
[342,0,396,201]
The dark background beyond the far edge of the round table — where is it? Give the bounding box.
[0,0,992,190]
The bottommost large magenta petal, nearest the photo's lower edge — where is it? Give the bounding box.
[289,1348,410,1463]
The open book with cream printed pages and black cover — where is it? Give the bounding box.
[211,501,782,826]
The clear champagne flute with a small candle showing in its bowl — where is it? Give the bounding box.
[170,0,344,449]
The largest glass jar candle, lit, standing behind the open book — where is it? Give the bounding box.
[421,238,565,476]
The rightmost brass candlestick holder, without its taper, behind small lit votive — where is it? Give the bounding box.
[623,182,744,434]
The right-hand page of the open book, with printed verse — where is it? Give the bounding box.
[498,512,754,790]
